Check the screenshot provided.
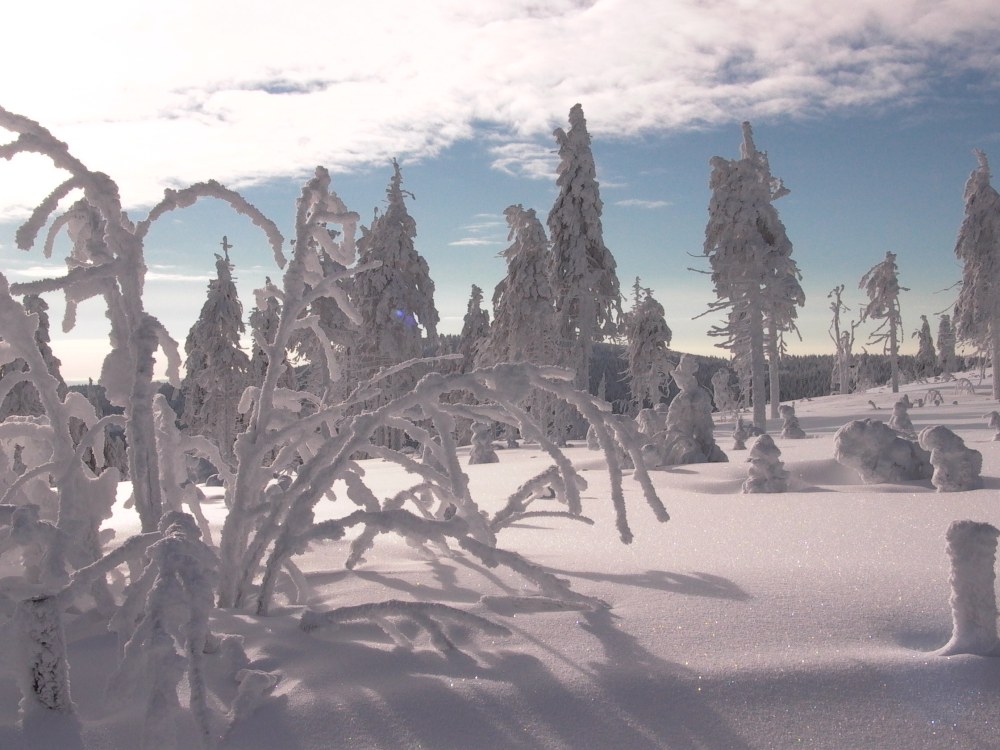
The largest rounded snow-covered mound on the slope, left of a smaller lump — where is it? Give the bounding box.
[833,419,933,484]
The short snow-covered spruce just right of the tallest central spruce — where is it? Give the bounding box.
[625,277,673,413]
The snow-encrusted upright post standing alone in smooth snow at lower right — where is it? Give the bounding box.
[937,521,1000,656]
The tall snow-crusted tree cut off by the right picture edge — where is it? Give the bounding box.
[954,151,1000,400]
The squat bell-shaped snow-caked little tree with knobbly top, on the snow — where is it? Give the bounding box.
[643,354,729,466]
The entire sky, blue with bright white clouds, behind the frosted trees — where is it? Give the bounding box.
[0,0,1000,379]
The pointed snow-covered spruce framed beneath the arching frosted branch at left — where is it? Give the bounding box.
[181,237,250,458]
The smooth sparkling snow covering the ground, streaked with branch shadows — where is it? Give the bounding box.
[0,383,1000,750]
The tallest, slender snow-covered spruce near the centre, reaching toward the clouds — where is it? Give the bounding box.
[548,104,622,392]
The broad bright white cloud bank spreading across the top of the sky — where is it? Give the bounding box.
[0,0,1000,217]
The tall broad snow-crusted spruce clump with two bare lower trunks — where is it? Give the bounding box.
[704,122,805,429]
